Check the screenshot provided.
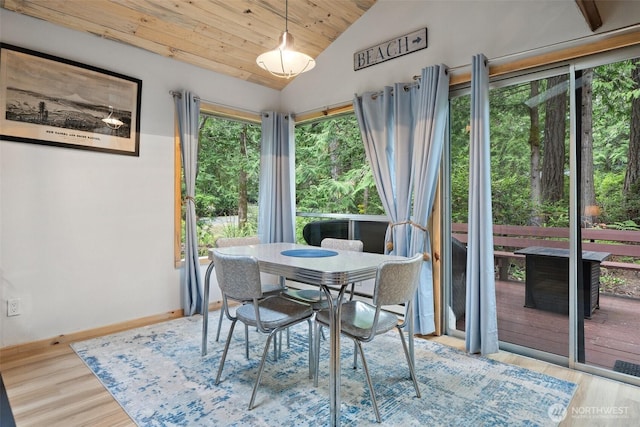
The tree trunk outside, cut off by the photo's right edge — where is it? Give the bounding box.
[623,59,640,211]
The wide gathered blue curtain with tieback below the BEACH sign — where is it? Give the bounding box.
[354,65,449,343]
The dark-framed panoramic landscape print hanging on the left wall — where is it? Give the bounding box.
[0,43,142,156]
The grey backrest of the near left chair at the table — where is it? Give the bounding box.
[213,251,262,301]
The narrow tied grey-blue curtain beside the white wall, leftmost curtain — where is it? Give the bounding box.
[173,91,208,316]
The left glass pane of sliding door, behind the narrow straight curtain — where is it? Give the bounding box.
[450,74,570,356]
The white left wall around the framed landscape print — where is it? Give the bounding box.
[0,9,280,347]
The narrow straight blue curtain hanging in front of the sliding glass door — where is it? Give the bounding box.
[465,55,498,355]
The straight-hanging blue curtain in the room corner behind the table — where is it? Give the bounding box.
[258,112,296,243]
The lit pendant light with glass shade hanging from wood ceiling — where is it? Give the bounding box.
[256,0,316,79]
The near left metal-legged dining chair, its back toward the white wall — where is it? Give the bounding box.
[213,251,313,410]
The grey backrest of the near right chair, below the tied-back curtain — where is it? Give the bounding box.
[373,254,424,307]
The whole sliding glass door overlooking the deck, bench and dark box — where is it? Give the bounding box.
[443,48,640,384]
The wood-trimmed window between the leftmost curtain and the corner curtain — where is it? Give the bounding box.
[175,106,261,266]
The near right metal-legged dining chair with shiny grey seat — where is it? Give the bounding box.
[314,254,423,422]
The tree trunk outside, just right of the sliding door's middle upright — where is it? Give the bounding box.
[580,68,599,226]
